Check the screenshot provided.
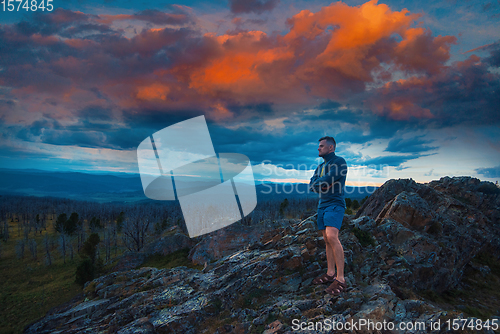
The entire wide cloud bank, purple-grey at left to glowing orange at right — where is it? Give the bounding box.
[4,0,456,119]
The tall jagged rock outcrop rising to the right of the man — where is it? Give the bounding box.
[356,177,500,292]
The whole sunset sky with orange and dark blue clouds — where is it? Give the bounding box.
[0,0,500,185]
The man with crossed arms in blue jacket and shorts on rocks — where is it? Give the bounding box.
[309,136,347,295]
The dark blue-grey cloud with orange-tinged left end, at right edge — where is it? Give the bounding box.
[366,55,500,129]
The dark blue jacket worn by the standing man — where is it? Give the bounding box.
[309,152,347,209]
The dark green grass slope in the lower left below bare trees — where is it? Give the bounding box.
[0,217,126,334]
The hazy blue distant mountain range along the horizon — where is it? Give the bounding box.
[0,168,376,202]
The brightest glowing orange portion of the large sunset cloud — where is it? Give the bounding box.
[166,0,456,113]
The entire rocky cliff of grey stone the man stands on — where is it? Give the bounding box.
[25,177,500,334]
